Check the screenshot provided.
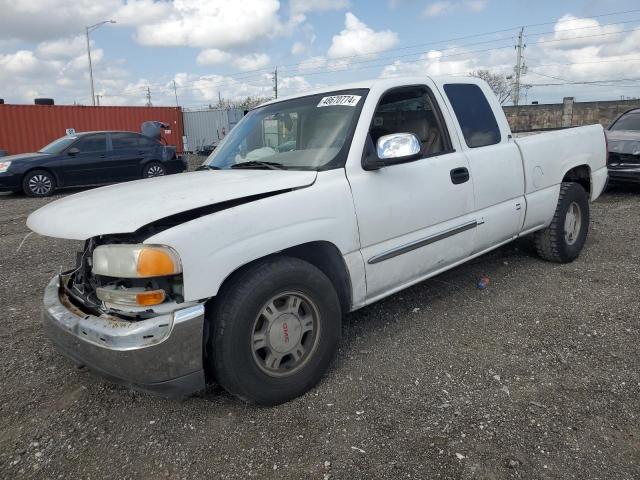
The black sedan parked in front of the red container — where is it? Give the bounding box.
[0,132,186,197]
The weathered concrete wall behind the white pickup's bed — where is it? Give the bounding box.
[504,97,640,132]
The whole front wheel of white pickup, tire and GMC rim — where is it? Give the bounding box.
[208,257,341,405]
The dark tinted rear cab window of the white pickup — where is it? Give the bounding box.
[444,83,501,148]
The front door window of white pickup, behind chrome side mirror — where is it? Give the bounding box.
[369,86,450,157]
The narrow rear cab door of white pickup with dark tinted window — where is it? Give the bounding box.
[443,83,526,252]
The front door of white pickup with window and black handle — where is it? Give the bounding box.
[347,85,477,301]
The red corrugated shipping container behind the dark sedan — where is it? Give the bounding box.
[0,105,183,155]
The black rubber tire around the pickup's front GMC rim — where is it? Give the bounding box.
[207,257,342,405]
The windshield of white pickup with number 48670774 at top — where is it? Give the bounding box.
[204,89,368,170]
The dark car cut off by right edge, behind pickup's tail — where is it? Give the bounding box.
[606,109,640,183]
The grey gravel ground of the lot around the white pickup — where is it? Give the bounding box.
[0,178,640,479]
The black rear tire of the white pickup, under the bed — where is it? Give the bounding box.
[534,182,589,263]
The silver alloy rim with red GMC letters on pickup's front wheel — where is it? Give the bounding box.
[251,292,320,377]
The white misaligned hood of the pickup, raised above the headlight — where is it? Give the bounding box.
[27,170,317,240]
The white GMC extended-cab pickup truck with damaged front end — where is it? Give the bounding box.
[27,77,607,405]
